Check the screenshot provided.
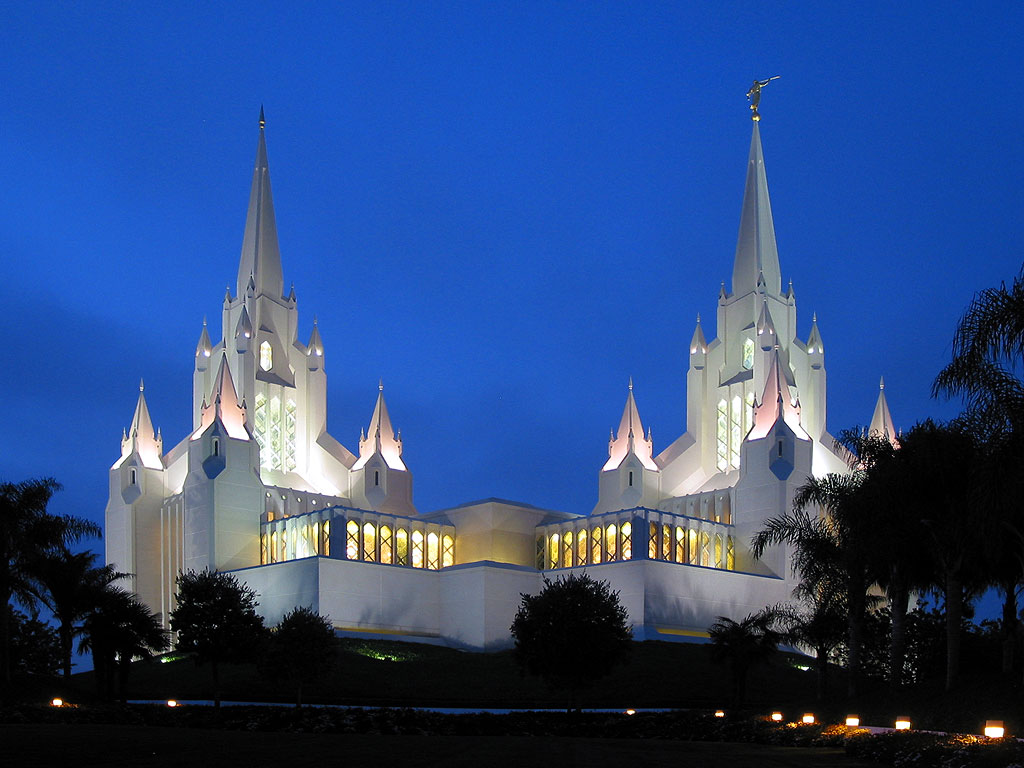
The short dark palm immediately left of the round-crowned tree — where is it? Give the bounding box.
[79,584,169,700]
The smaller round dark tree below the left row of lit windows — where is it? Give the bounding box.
[262,607,338,707]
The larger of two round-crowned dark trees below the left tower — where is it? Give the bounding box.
[171,570,266,707]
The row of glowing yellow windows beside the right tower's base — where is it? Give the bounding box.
[537,521,736,570]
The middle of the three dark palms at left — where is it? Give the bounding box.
[30,547,125,678]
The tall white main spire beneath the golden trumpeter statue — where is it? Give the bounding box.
[732,123,782,296]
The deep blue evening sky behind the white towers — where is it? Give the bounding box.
[0,2,1024,618]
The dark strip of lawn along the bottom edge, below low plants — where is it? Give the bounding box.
[0,724,874,768]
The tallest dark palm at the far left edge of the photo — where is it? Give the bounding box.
[0,477,101,683]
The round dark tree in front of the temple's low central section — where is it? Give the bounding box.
[511,573,633,711]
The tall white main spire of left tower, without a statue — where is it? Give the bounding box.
[238,106,285,299]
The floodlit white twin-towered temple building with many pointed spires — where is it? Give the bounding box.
[105,111,895,650]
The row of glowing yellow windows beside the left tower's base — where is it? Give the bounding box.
[260,520,455,570]
